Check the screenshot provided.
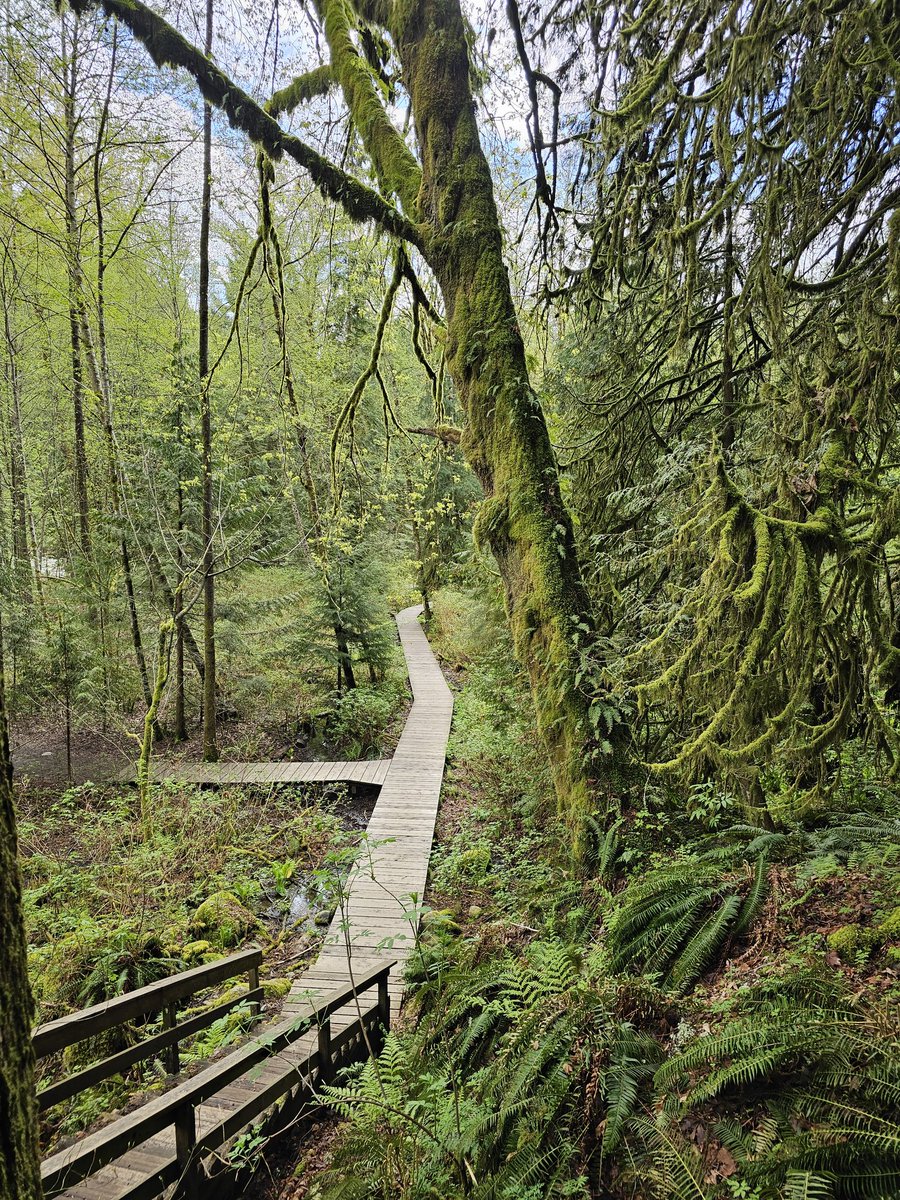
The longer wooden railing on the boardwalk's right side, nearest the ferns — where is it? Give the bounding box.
[41,956,394,1200]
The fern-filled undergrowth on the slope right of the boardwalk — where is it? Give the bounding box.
[314,593,900,1200]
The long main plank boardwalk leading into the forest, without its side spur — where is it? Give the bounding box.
[43,607,452,1200]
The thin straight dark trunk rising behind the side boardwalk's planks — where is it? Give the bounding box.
[199,0,218,762]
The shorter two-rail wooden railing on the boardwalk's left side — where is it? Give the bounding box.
[32,949,263,1112]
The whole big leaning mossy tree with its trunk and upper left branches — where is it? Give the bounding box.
[63,0,616,822]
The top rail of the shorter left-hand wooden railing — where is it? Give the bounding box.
[31,948,263,1058]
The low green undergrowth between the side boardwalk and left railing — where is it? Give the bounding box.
[19,784,359,1139]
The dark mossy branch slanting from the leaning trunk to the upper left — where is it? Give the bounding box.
[65,0,420,246]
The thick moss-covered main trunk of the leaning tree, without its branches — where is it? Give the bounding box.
[395,0,602,818]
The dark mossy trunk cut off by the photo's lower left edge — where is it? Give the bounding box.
[0,619,41,1200]
